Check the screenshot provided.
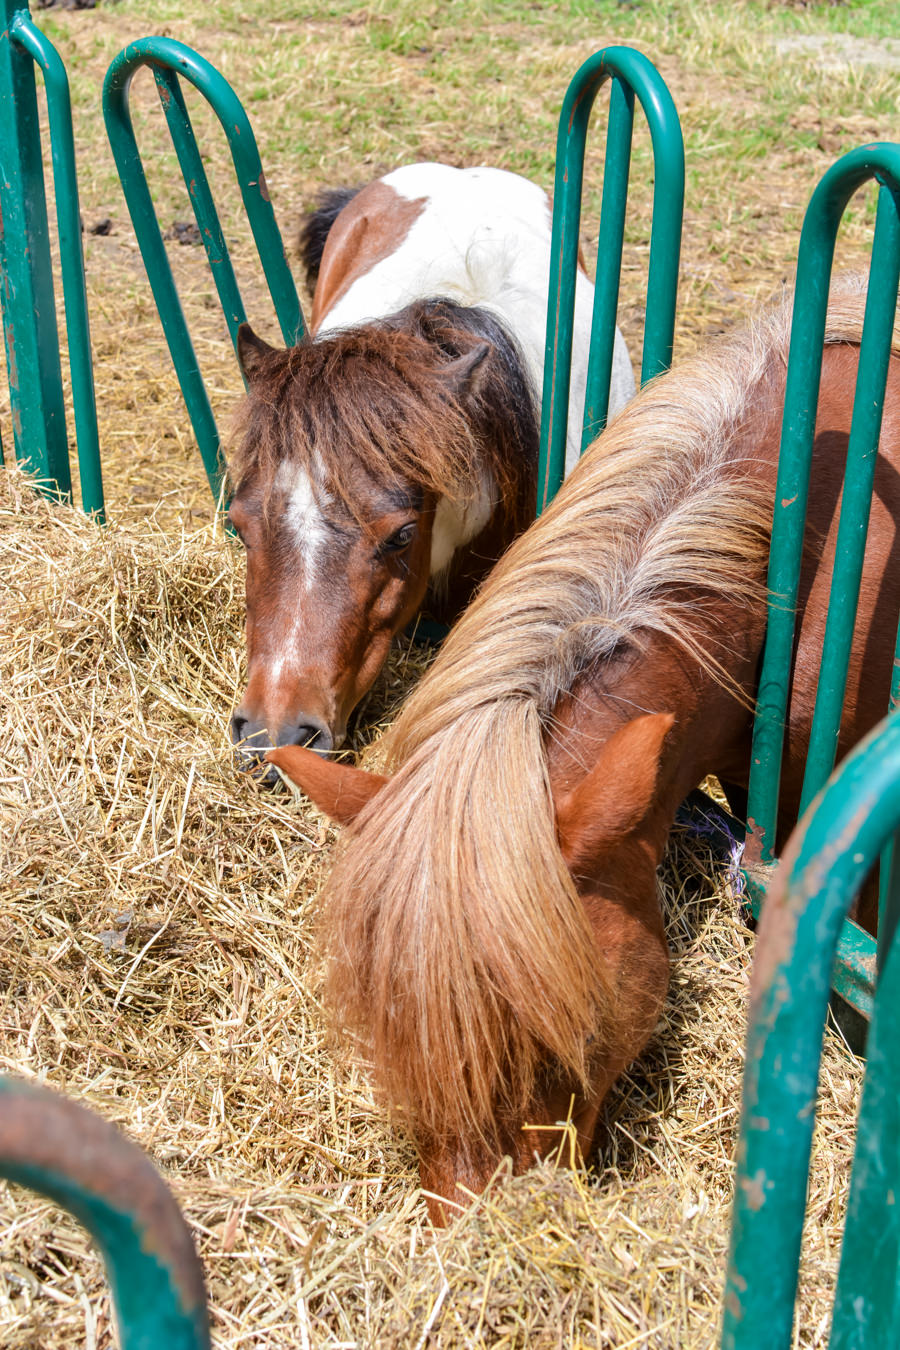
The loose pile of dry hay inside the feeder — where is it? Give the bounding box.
[0,461,860,1350]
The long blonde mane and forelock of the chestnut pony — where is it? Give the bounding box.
[322,278,879,1149]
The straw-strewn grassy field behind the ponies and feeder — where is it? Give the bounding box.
[7,0,900,521]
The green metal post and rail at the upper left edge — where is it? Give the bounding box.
[0,0,103,520]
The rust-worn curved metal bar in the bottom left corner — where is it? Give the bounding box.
[0,1077,210,1350]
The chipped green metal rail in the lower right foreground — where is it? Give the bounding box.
[722,713,900,1350]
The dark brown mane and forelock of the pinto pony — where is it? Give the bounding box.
[229,301,538,528]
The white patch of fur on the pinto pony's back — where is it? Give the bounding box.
[318,163,634,473]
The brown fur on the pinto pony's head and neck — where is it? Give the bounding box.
[231,301,537,763]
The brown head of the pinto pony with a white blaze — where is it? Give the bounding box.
[229,321,493,764]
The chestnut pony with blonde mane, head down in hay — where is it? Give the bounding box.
[269,278,900,1220]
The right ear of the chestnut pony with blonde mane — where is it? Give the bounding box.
[556,713,675,873]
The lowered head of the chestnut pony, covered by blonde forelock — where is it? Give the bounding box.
[267,714,672,1222]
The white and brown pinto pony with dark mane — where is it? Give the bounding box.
[231,163,634,760]
